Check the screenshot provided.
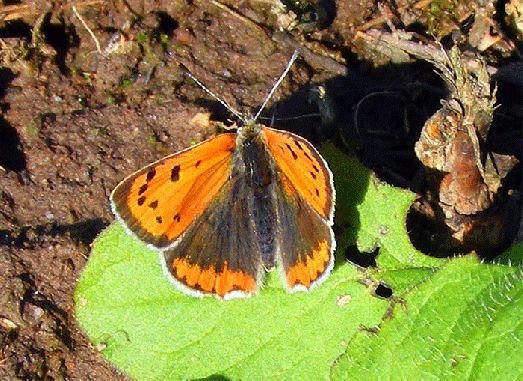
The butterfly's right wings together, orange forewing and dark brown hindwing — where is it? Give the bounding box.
[264,128,336,292]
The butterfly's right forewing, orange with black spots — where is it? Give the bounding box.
[263,127,335,223]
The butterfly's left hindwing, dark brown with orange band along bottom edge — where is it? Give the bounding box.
[160,173,263,299]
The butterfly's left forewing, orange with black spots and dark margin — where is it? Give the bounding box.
[111,133,236,249]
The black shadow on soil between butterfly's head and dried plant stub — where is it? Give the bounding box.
[260,59,446,192]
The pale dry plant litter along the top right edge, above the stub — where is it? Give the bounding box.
[356,0,522,63]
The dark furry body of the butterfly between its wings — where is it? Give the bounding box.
[236,122,277,269]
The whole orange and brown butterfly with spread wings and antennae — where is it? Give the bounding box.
[110,53,336,299]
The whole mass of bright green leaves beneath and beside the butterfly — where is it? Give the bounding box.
[75,146,523,380]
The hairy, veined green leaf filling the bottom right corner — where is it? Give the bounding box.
[331,256,523,380]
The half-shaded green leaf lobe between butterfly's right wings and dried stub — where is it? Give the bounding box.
[322,145,444,268]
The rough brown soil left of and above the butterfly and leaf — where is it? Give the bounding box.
[0,0,520,380]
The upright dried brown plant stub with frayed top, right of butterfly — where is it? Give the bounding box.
[415,47,517,252]
